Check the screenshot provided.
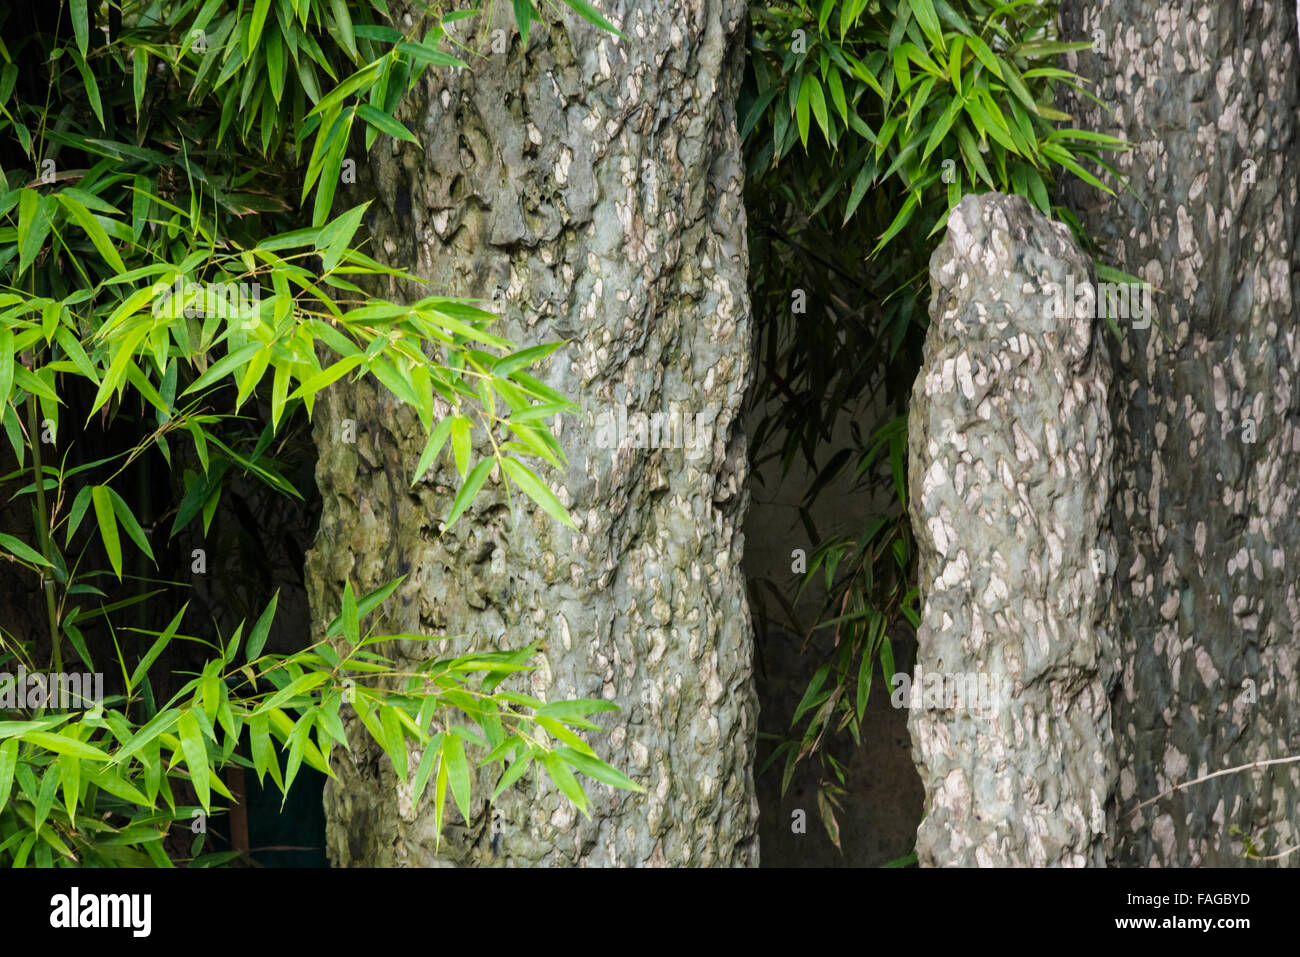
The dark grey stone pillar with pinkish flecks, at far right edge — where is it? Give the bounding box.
[1062,0,1300,866]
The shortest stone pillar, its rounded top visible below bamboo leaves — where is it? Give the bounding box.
[907,194,1115,866]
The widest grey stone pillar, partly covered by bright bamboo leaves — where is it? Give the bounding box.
[302,0,758,866]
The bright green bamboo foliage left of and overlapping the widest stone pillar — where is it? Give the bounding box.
[0,0,640,866]
